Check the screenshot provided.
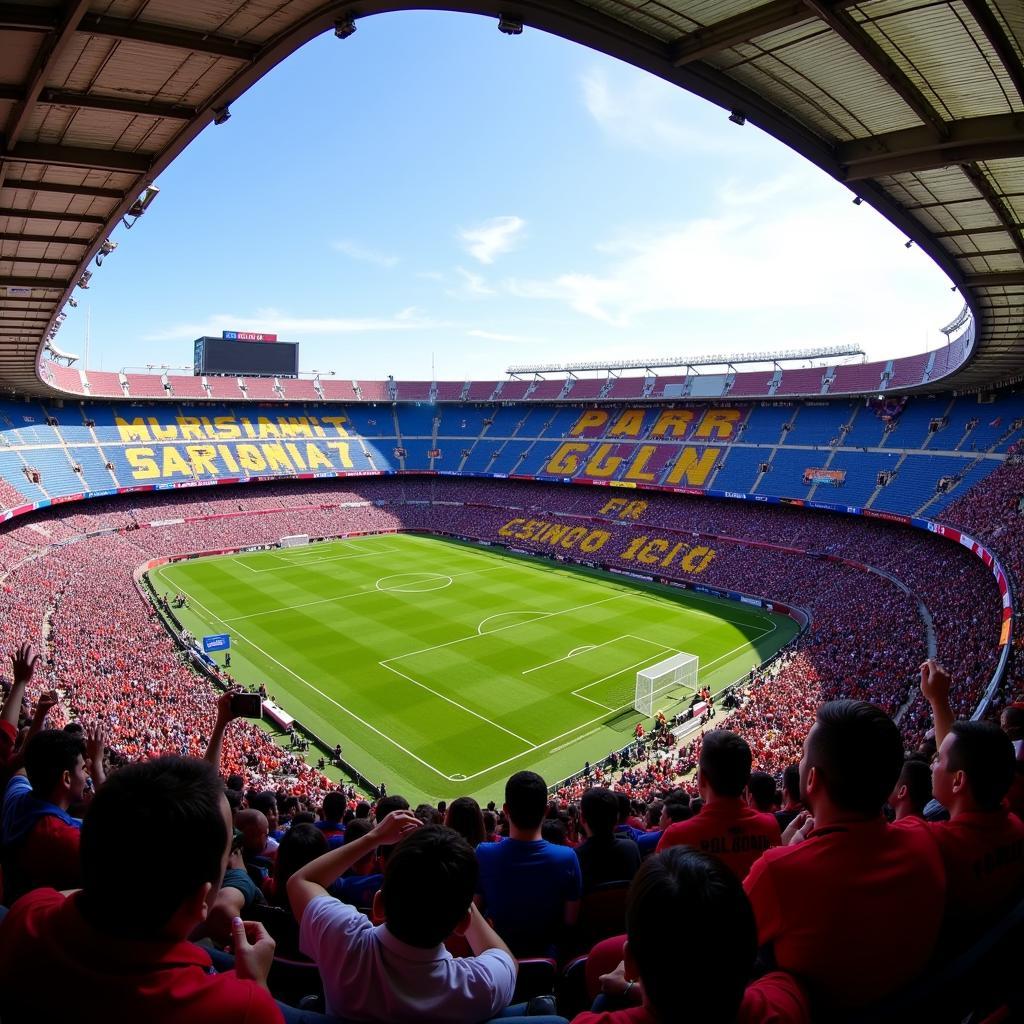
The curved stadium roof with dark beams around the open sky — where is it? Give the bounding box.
[0,0,1024,394]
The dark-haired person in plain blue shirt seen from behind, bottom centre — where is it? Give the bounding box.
[476,771,582,956]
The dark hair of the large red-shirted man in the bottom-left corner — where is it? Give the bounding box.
[80,757,229,938]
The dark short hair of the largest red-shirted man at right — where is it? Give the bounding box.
[807,700,903,816]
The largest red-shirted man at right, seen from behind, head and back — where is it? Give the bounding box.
[744,700,945,1007]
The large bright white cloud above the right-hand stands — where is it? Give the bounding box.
[504,180,958,357]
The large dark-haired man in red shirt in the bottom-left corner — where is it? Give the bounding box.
[0,757,282,1024]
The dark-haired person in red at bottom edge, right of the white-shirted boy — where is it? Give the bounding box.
[572,847,810,1024]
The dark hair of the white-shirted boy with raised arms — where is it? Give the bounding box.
[383,825,479,949]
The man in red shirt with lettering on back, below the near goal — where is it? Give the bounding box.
[657,729,780,881]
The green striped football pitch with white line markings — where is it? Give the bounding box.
[151,534,797,806]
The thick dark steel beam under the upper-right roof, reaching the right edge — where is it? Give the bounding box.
[836,114,1024,181]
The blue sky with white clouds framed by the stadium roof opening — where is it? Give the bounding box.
[70,12,962,379]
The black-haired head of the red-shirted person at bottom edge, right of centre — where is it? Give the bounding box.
[626,846,758,1024]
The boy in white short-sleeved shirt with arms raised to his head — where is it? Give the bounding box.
[288,810,517,1024]
